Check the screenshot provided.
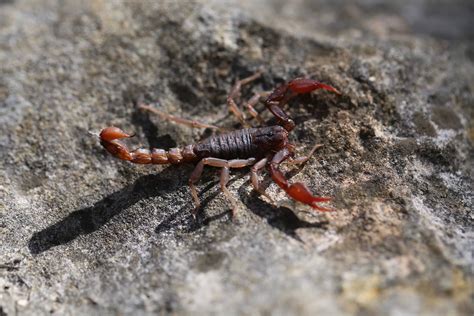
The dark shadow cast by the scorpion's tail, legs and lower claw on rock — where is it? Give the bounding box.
[28,166,327,255]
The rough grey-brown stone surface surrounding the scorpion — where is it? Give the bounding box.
[0,0,474,316]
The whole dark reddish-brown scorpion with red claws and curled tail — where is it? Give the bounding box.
[99,73,340,217]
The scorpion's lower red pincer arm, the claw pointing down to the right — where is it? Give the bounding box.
[270,148,332,212]
